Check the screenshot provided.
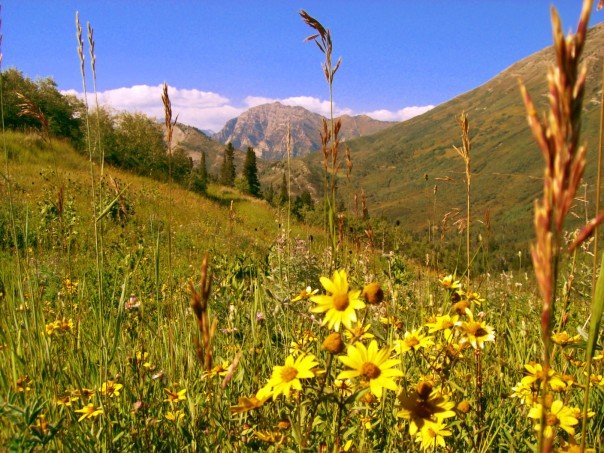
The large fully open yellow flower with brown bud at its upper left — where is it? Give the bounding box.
[337,340,403,398]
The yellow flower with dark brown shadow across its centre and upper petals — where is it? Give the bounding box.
[396,382,455,436]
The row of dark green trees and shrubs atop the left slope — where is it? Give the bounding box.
[0,68,313,214]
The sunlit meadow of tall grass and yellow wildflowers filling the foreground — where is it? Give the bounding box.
[0,1,604,452]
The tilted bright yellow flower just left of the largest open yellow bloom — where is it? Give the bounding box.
[256,354,319,400]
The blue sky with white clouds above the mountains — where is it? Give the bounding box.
[2,0,604,130]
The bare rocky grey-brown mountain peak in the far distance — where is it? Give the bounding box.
[213,102,395,160]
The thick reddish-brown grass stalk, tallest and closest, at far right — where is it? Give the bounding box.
[520,0,593,451]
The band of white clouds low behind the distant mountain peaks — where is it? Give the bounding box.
[63,85,434,131]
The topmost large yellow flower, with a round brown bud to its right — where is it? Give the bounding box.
[310,270,365,332]
